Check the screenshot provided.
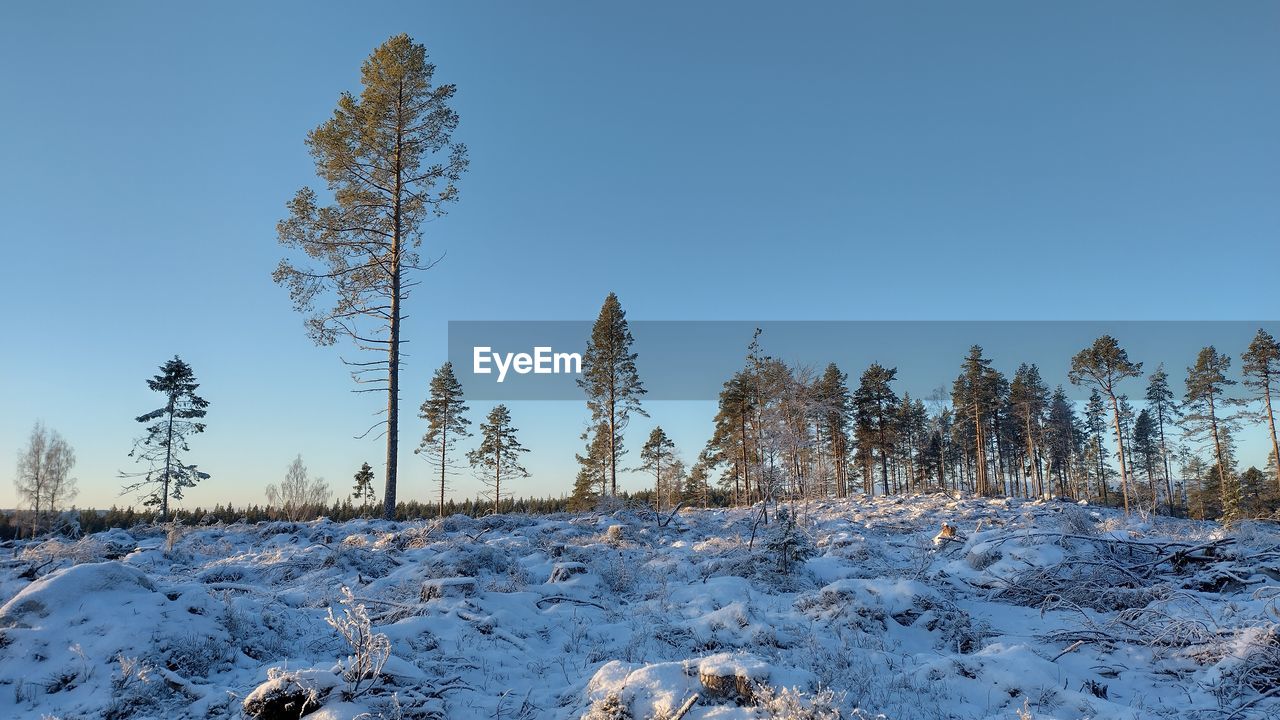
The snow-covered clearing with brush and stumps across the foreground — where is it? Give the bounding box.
[0,496,1280,720]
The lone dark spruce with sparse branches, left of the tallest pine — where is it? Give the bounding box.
[120,356,210,521]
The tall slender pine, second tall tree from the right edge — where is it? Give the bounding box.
[1183,345,1240,524]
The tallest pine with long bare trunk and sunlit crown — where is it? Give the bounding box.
[273,35,467,519]
